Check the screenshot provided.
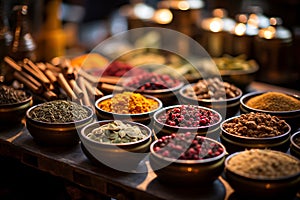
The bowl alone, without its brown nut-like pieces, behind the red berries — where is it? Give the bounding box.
[179,84,243,119]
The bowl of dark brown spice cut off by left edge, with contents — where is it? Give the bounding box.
[0,85,33,126]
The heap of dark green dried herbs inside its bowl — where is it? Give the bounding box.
[29,100,90,123]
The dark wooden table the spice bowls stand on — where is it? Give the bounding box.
[0,82,300,200]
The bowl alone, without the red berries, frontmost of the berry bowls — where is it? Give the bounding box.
[149,134,226,186]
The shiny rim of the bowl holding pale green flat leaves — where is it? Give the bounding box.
[80,120,152,147]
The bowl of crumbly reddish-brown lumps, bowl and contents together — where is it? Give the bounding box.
[220,112,291,153]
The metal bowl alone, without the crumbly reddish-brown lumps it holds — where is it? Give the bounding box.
[220,116,291,154]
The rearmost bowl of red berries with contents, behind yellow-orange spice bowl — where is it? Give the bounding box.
[124,72,184,106]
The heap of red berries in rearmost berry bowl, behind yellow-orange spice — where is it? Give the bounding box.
[125,73,180,91]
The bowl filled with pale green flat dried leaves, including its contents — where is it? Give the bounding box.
[79,120,152,172]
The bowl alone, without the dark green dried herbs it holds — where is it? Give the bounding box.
[26,104,94,146]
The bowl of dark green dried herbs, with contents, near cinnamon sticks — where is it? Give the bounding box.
[26,100,95,146]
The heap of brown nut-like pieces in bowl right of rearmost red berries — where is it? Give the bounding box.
[184,78,240,100]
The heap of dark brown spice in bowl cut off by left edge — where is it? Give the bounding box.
[0,85,28,105]
